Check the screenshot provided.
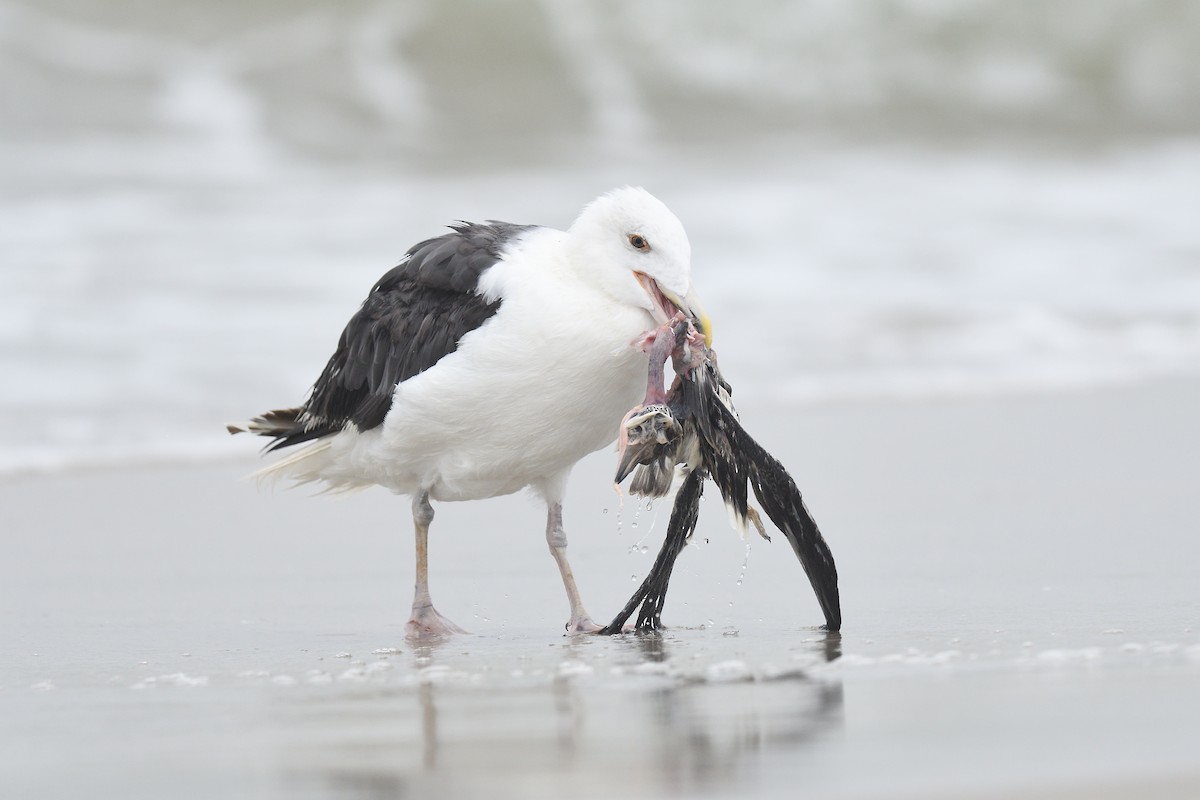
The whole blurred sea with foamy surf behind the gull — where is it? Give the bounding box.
[0,0,1200,469]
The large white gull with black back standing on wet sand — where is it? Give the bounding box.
[228,187,712,636]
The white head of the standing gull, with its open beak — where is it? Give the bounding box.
[570,187,713,347]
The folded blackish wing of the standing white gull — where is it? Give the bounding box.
[270,221,530,450]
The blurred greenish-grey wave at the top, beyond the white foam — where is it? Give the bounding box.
[0,0,1200,160]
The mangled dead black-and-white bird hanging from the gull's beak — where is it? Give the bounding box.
[600,314,841,633]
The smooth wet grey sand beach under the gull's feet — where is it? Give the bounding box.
[0,379,1200,800]
